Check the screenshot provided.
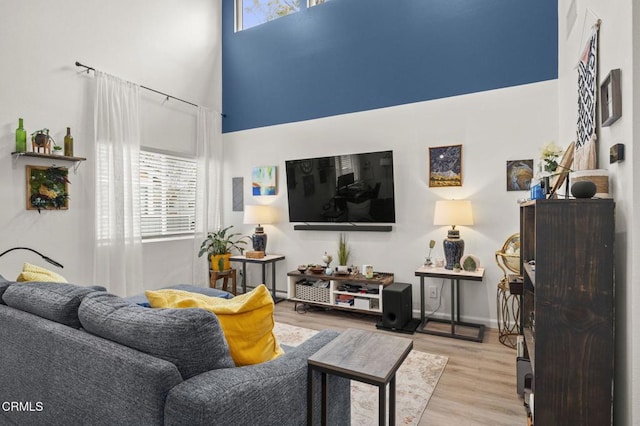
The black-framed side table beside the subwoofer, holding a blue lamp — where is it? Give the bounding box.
[416,266,484,342]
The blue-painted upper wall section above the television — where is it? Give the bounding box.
[222,0,558,132]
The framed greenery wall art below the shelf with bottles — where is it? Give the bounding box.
[27,166,69,213]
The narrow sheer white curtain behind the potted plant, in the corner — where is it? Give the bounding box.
[193,107,223,286]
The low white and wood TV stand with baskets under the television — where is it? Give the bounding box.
[287,271,393,315]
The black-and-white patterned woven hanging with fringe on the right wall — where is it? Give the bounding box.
[573,20,600,170]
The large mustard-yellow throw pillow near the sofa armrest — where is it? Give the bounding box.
[145,284,284,366]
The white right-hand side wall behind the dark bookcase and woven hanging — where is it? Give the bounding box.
[558,0,640,425]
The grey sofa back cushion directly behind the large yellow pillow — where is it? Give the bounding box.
[79,292,235,380]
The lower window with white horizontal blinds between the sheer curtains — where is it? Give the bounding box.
[140,150,197,238]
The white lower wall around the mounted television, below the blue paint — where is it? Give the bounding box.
[223,80,558,327]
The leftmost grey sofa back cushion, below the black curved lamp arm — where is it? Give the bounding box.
[2,282,96,328]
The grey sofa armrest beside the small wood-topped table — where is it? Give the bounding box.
[165,330,351,426]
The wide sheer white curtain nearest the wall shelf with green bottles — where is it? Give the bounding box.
[94,71,144,296]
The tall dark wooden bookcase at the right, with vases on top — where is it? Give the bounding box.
[519,199,615,426]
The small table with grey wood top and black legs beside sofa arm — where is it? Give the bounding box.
[307,328,413,426]
